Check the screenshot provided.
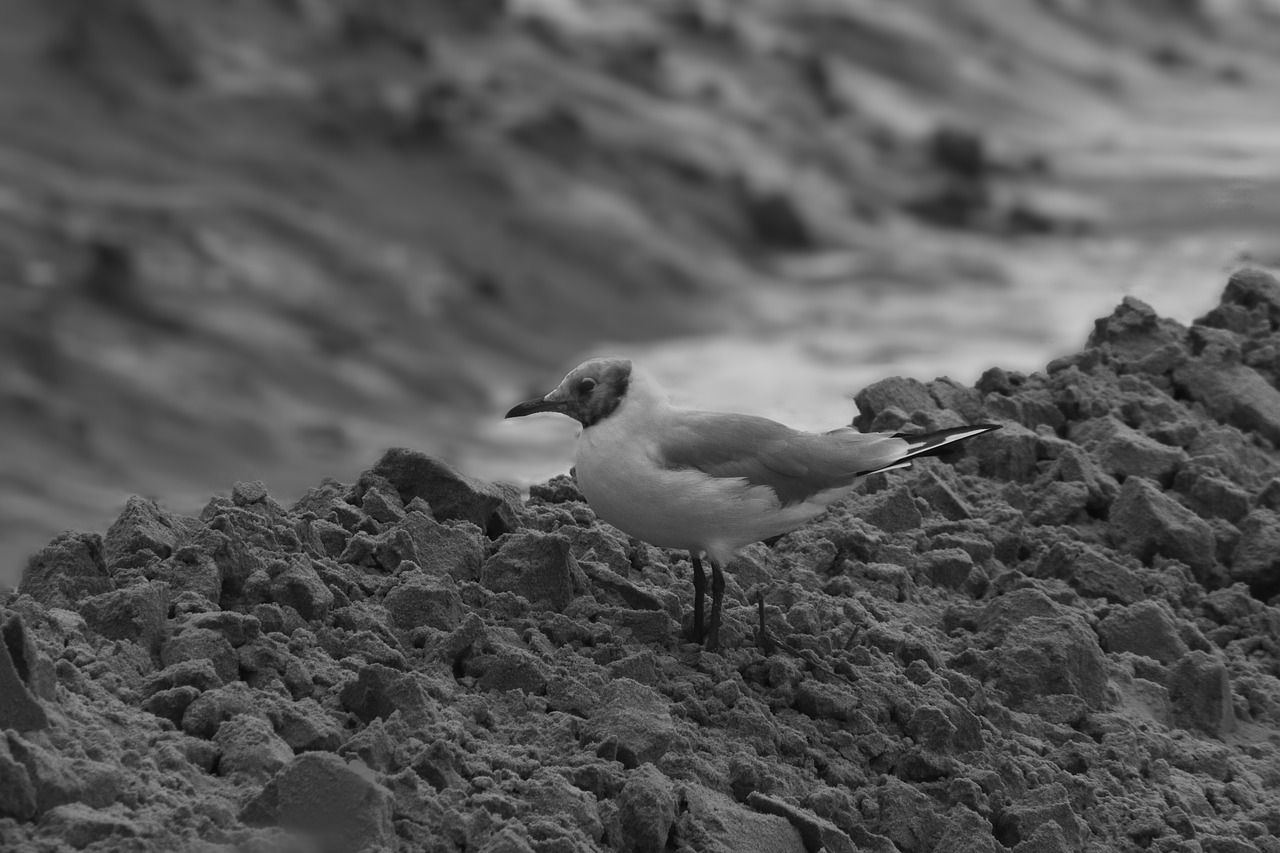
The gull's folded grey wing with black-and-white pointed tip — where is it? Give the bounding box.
[657,411,1000,506]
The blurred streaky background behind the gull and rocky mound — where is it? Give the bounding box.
[0,0,1280,584]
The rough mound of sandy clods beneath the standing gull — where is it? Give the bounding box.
[0,273,1280,853]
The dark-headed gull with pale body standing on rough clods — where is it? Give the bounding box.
[506,357,1000,651]
